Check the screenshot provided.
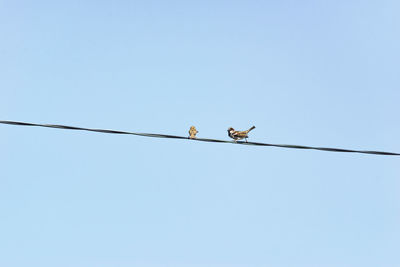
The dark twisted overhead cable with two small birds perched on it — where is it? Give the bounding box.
[0,121,400,156]
